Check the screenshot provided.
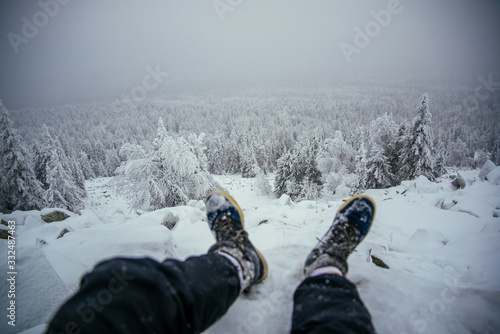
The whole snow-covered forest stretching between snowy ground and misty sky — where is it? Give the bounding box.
[0,74,500,212]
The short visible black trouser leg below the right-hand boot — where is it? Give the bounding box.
[292,275,375,334]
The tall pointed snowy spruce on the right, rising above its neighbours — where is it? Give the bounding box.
[399,94,435,181]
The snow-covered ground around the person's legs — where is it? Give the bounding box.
[0,170,500,334]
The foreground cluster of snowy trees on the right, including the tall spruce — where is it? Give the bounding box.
[275,95,446,199]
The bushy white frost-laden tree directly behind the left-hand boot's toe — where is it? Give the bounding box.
[116,118,220,211]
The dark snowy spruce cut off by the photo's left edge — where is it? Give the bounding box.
[0,101,45,213]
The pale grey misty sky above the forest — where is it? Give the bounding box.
[0,0,500,108]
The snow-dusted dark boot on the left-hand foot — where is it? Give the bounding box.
[206,191,268,290]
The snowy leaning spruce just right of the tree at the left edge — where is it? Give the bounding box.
[36,124,87,212]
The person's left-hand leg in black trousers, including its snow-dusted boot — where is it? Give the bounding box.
[48,192,267,334]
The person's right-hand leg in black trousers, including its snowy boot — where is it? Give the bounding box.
[292,196,375,334]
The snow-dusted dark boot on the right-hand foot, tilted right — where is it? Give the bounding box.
[304,195,375,276]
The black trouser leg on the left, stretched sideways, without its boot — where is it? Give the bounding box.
[48,254,240,334]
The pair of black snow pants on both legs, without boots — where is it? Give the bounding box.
[47,254,374,334]
